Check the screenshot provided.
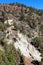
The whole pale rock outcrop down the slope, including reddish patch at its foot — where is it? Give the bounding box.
[5,20,42,65]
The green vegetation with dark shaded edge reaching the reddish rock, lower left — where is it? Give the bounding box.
[0,43,24,65]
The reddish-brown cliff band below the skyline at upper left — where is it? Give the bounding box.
[0,4,21,12]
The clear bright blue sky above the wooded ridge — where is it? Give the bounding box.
[0,0,43,9]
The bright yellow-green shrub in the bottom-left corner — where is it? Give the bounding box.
[0,43,18,65]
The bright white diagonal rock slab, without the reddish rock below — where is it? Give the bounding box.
[14,33,41,62]
